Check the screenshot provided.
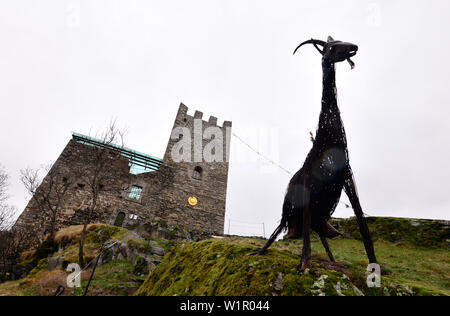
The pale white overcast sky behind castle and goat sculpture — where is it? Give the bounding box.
[0,0,450,235]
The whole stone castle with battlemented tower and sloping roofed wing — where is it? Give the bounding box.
[16,104,231,235]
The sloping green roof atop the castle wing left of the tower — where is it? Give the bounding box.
[72,133,163,174]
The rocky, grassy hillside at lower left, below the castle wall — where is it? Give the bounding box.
[0,224,173,296]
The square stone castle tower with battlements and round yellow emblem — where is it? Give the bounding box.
[158,104,231,234]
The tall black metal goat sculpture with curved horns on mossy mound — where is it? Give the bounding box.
[253,37,376,271]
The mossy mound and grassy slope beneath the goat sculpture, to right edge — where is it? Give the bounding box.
[137,237,450,296]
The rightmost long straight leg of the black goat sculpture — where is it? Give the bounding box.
[344,167,377,263]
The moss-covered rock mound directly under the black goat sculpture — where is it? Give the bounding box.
[136,238,446,296]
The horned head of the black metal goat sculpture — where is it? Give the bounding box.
[294,36,358,69]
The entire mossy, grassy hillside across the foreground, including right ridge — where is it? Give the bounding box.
[0,218,450,296]
